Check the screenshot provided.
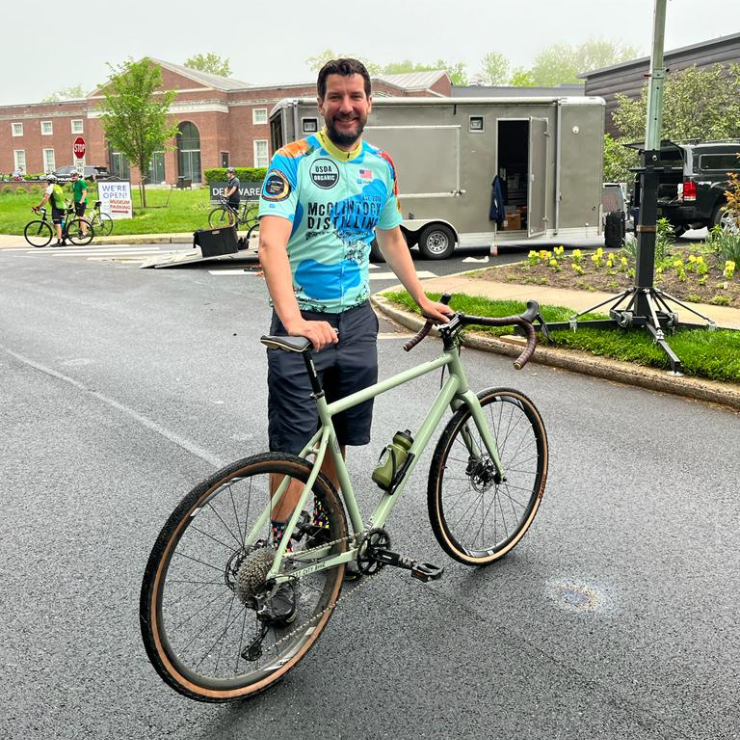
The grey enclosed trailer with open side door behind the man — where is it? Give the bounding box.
[270,95,605,259]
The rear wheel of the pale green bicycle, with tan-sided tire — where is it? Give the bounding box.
[139,453,347,702]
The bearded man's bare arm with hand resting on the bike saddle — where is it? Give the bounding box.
[259,216,337,351]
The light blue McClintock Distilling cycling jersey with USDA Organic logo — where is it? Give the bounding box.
[259,129,402,313]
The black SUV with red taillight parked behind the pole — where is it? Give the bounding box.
[631,140,740,236]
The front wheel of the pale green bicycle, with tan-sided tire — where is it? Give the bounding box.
[427,388,548,565]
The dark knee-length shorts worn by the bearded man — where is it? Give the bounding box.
[267,301,378,455]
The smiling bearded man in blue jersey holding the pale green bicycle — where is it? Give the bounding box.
[259,59,452,600]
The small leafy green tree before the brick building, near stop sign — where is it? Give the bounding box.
[100,57,178,208]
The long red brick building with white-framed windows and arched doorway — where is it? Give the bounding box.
[0,59,451,184]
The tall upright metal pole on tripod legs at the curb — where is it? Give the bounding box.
[635,0,668,310]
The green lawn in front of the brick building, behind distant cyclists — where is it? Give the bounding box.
[0,183,247,235]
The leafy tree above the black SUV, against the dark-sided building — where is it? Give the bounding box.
[613,63,740,141]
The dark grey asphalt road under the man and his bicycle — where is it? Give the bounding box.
[0,250,740,740]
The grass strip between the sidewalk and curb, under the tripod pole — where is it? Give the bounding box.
[383,291,740,383]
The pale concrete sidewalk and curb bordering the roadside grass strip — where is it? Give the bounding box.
[373,275,740,411]
